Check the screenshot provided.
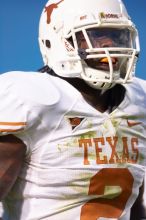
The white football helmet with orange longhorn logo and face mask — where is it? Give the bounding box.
[39,0,140,89]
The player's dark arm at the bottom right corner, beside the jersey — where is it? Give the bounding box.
[130,180,146,220]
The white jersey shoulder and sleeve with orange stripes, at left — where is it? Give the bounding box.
[0,72,60,152]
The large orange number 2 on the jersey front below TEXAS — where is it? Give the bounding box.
[80,168,134,220]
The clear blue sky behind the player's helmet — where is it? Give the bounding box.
[0,0,146,79]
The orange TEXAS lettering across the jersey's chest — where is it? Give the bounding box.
[78,136,139,165]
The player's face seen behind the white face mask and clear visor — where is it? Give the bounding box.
[76,27,133,71]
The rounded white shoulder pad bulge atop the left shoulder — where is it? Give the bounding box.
[0,71,60,105]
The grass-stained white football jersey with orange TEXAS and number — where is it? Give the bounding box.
[0,72,146,220]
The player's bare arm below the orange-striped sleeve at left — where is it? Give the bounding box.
[0,135,26,200]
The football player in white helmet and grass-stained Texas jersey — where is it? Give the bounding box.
[0,0,146,220]
